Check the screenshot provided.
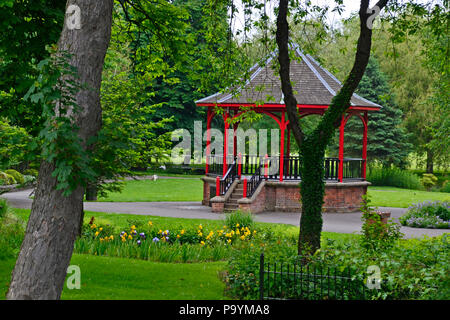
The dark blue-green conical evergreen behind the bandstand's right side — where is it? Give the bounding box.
[330,57,412,168]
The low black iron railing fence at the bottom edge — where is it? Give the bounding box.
[259,254,367,300]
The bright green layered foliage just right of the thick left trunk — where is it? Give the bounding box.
[92,40,171,196]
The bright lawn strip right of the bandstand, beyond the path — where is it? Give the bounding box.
[368,186,450,208]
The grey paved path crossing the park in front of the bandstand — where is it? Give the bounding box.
[0,190,449,238]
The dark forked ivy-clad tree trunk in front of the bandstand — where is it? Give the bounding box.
[276,0,388,255]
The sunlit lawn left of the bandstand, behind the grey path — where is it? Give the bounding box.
[99,178,203,202]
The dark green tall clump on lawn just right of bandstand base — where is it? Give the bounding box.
[366,167,423,190]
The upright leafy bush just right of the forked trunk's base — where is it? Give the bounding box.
[360,195,403,252]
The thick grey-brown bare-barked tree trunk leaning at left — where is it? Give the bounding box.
[7,0,113,299]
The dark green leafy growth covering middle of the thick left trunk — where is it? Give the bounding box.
[24,48,95,196]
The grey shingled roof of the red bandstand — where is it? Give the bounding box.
[196,47,381,110]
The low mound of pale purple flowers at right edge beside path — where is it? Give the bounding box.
[399,201,450,229]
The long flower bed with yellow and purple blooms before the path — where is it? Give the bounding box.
[74,218,258,262]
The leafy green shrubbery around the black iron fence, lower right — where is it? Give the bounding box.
[225,235,450,300]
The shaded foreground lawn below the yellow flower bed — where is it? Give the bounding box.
[0,254,226,300]
